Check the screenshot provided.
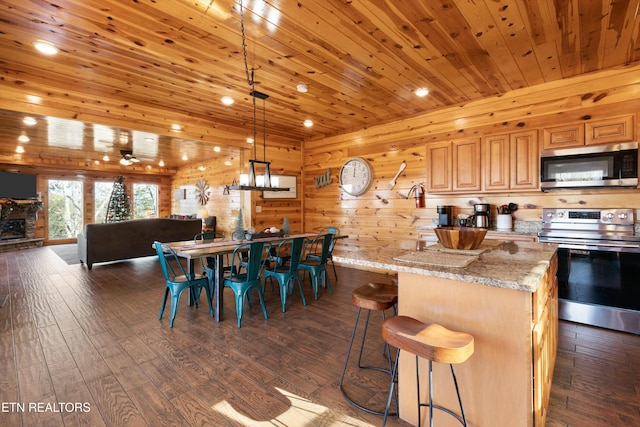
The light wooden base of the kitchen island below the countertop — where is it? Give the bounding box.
[398,262,558,427]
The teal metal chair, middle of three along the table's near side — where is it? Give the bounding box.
[263,237,307,313]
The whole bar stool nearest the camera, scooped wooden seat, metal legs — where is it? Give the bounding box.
[382,316,474,427]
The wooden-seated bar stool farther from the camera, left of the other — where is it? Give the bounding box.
[340,283,398,415]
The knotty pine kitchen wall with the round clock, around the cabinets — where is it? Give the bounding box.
[303,67,640,250]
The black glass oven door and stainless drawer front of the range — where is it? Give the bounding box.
[558,247,640,335]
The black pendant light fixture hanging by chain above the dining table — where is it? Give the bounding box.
[225,0,289,192]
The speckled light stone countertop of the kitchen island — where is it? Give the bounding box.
[332,242,557,292]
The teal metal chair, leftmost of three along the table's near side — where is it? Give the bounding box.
[224,242,271,328]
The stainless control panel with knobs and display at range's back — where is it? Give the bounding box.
[542,208,634,225]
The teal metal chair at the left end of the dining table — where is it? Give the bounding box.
[153,241,213,328]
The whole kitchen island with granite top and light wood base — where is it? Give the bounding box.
[333,240,558,427]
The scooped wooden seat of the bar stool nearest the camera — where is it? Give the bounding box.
[382,316,473,363]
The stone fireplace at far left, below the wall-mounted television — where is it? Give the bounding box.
[0,199,44,252]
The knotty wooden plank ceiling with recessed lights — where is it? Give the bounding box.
[0,0,640,168]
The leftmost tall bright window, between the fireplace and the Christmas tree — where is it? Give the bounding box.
[48,179,83,239]
